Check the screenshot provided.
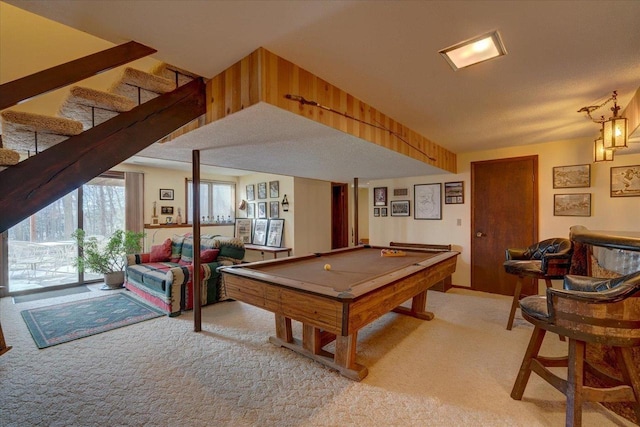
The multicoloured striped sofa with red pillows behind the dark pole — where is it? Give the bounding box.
[124,234,245,316]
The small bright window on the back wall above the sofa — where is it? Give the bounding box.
[187,180,236,223]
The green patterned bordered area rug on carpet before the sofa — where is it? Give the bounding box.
[20,292,164,348]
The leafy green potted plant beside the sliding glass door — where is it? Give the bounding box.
[72,229,144,289]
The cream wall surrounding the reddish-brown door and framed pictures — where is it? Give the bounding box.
[369,139,640,286]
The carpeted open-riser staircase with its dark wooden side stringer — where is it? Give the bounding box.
[0,45,206,232]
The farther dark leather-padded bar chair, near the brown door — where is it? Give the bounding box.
[504,238,573,330]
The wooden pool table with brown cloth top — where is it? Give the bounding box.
[220,245,458,381]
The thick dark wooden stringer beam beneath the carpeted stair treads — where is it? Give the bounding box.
[0,78,206,232]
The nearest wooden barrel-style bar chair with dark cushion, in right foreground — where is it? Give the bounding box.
[511,271,640,426]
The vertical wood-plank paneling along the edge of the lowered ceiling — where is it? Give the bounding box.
[207,48,457,173]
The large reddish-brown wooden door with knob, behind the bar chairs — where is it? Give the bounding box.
[471,156,538,295]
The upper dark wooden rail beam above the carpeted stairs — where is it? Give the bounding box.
[0,41,157,110]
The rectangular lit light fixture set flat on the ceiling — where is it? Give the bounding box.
[439,31,507,71]
